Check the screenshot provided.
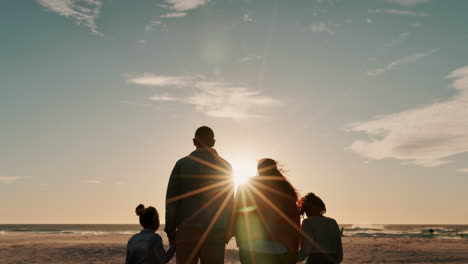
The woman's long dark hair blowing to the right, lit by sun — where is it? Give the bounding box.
[257,158,298,202]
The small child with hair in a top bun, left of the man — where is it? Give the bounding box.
[126,204,175,264]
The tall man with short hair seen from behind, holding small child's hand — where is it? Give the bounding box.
[164,126,234,264]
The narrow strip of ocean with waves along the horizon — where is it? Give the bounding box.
[0,224,468,240]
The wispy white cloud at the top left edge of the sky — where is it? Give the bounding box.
[38,0,103,36]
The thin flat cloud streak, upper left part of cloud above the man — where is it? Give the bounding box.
[124,72,194,86]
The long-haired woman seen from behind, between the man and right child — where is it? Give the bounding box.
[234,159,300,264]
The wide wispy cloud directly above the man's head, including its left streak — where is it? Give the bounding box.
[124,73,281,119]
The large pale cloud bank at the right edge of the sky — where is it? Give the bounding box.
[348,66,468,167]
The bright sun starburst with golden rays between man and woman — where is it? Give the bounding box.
[167,156,330,263]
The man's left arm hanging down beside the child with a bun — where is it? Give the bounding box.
[164,162,180,246]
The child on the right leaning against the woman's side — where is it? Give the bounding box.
[297,193,343,264]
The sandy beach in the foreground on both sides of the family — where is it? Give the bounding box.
[0,233,468,264]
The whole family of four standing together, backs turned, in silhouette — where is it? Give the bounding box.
[126,126,343,264]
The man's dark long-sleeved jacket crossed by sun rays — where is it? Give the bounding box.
[164,148,234,239]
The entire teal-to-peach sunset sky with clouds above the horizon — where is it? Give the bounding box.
[0,0,468,224]
